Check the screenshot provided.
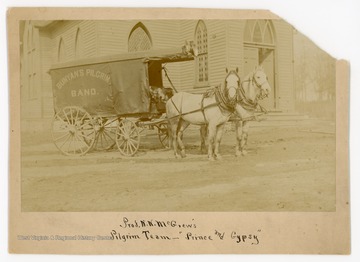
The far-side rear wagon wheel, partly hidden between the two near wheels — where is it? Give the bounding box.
[94,117,118,150]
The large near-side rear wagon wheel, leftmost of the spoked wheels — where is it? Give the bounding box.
[52,106,95,156]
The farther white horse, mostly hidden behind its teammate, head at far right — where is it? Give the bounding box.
[200,66,271,156]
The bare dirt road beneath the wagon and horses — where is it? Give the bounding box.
[21,120,335,212]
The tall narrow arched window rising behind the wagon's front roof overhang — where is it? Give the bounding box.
[195,21,209,86]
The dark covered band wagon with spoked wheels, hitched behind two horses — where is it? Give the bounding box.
[49,44,194,156]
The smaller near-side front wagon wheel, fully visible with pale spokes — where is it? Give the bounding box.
[116,119,140,156]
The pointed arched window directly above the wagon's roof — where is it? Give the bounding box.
[128,23,152,52]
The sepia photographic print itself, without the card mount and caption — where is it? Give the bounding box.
[19,19,336,212]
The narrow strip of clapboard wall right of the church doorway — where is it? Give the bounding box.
[273,20,294,111]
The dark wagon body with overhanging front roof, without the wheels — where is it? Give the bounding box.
[50,48,194,116]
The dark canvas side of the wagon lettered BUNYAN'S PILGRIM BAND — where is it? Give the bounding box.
[50,59,150,115]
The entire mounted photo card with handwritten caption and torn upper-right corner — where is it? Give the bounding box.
[7,5,350,254]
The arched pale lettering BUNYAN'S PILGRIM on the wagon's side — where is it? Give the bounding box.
[56,69,111,90]
